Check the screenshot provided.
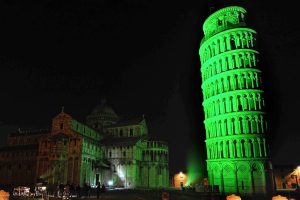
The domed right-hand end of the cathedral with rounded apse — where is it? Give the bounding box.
[86,104,169,188]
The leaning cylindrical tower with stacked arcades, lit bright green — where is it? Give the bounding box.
[199,6,273,194]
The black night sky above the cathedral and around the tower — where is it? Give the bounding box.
[0,0,300,173]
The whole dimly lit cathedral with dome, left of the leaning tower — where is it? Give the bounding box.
[0,104,169,188]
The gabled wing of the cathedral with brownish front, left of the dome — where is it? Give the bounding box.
[37,112,103,187]
